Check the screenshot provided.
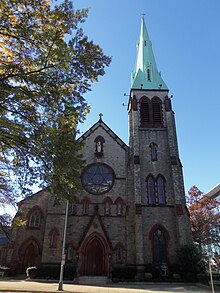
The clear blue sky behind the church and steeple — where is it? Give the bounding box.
[73,0,220,193]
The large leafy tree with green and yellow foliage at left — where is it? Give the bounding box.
[0,0,110,214]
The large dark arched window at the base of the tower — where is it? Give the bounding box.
[153,229,167,265]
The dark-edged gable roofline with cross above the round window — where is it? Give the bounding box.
[78,117,128,151]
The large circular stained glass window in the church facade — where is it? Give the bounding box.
[82,163,114,194]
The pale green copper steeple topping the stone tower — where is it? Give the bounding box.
[131,16,168,90]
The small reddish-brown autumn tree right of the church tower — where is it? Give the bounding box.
[187,186,220,251]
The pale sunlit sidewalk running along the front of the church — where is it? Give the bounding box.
[0,278,211,293]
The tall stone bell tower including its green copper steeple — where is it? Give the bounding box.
[127,16,191,273]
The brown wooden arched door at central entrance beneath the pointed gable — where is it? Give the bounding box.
[85,238,105,276]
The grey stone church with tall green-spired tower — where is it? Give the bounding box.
[7,17,191,276]
